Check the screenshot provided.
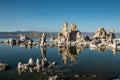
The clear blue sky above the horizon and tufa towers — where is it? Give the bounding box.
[0,0,120,32]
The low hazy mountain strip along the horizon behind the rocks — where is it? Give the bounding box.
[0,31,120,38]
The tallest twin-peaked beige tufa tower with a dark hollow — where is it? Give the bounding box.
[58,22,84,43]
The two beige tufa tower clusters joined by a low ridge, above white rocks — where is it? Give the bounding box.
[58,22,115,43]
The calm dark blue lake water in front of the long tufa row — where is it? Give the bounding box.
[0,39,120,80]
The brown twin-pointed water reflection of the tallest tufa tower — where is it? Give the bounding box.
[58,45,84,64]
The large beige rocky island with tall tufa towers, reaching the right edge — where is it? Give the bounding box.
[50,22,120,50]
